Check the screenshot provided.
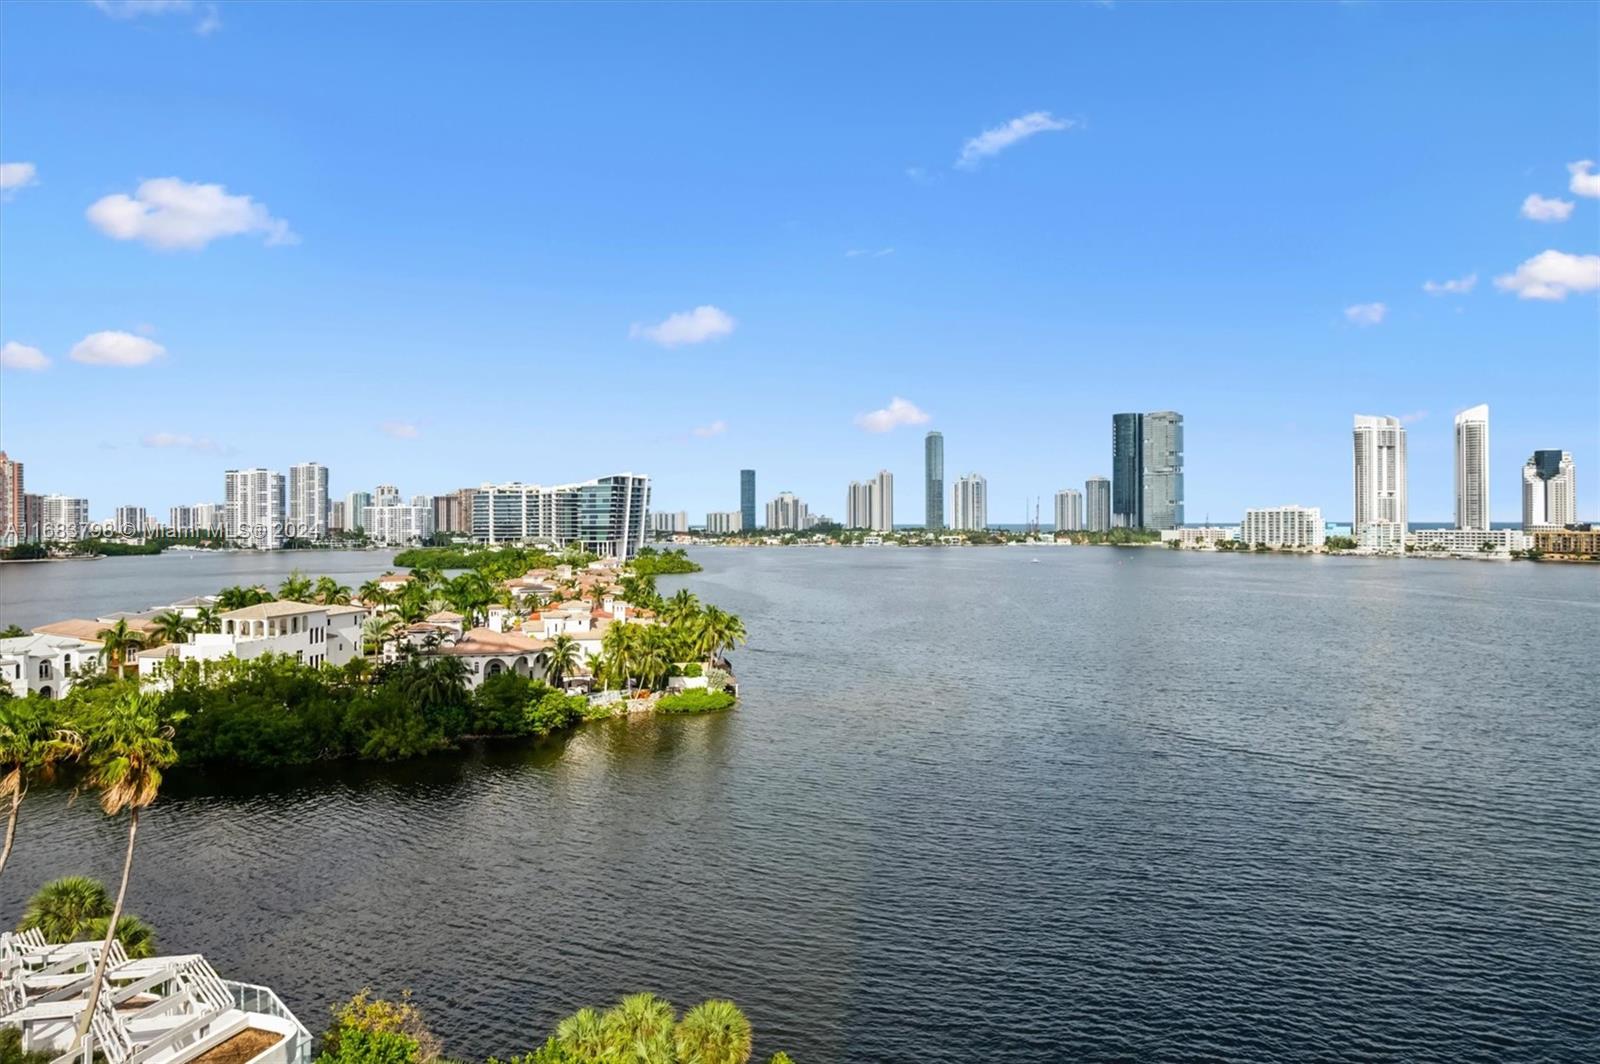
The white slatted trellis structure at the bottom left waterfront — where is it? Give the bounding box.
[0,931,310,1064]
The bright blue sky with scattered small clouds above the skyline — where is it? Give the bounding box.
[0,2,1600,522]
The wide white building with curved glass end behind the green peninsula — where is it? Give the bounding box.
[472,474,650,558]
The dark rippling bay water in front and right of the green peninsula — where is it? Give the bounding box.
[0,547,1600,1064]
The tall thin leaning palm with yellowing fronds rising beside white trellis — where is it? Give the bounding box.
[72,691,178,1050]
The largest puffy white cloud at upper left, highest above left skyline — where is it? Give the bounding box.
[86,178,299,251]
